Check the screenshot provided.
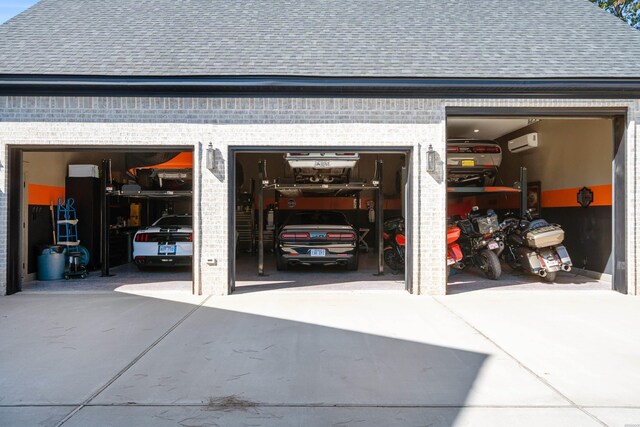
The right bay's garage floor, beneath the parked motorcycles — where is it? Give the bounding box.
[447,266,611,294]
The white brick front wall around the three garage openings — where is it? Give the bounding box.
[0,97,640,295]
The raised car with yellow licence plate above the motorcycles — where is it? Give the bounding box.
[447,139,502,187]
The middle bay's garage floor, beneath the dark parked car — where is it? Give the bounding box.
[235,252,405,293]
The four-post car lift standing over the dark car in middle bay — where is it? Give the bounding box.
[258,160,384,276]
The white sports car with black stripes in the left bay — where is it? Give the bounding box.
[133,215,193,269]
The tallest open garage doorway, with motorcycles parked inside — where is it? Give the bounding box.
[447,111,624,293]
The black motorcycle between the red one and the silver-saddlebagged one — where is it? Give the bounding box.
[453,206,505,280]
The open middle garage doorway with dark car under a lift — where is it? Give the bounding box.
[232,148,410,292]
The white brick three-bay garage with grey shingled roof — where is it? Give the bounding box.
[0,0,640,295]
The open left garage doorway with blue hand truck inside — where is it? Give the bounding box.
[9,147,193,293]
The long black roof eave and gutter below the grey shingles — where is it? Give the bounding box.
[0,74,640,99]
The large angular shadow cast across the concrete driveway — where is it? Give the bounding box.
[0,294,487,426]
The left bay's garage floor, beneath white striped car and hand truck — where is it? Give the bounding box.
[22,264,193,294]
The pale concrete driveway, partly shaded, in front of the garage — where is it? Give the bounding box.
[0,291,640,427]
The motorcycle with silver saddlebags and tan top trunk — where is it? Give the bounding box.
[500,209,573,282]
